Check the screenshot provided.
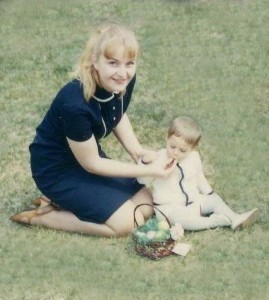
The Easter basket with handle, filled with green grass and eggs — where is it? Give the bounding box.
[133,204,175,260]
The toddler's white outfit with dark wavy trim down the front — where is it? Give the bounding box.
[138,149,234,230]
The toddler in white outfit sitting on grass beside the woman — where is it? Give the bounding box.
[138,116,258,230]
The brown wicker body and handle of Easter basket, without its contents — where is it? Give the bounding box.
[133,204,175,260]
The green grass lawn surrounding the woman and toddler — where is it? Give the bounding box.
[0,0,269,300]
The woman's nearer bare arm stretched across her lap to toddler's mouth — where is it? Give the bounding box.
[67,136,175,177]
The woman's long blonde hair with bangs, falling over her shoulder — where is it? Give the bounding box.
[70,24,139,101]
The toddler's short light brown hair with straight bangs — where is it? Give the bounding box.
[168,116,202,147]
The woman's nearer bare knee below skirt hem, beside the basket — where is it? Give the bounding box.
[106,200,144,236]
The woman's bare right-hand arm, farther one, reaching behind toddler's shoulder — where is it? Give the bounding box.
[114,113,156,162]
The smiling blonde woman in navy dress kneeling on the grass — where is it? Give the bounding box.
[11,25,175,237]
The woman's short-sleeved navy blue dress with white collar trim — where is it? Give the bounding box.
[29,78,143,223]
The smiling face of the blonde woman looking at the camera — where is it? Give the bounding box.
[93,46,136,93]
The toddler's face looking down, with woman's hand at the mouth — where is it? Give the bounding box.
[166,135,193,162]
